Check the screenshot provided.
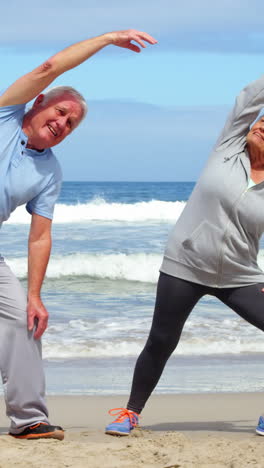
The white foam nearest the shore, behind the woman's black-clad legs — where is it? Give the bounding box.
[43,310,264,359]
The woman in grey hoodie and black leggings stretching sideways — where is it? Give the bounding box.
[106,77,264,435]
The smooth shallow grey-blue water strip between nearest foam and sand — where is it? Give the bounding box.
[40,353,264,394]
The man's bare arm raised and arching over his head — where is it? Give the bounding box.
[0,29,157,107]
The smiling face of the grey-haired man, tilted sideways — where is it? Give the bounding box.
[23,93,83,150]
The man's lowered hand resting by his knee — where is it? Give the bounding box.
[27,297,49,340]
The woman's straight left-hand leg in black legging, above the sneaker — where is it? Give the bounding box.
[127,273,206,414]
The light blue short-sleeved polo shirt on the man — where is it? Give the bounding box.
[0,100,62,225]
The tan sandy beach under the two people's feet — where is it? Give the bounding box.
[0,393,264,468]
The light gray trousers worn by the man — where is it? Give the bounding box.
[0,258,49,434]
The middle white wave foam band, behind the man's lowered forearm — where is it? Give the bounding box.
[7,253,162,283]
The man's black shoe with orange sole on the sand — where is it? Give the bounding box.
[9,422,64,440]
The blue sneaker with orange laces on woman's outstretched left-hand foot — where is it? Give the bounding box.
[105,408,139,435]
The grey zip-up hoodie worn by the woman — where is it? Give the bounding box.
[161,76,264,288]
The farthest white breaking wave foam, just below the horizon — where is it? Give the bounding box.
[4,198,185,224]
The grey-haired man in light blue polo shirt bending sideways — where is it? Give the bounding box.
[0,30,156,440]
